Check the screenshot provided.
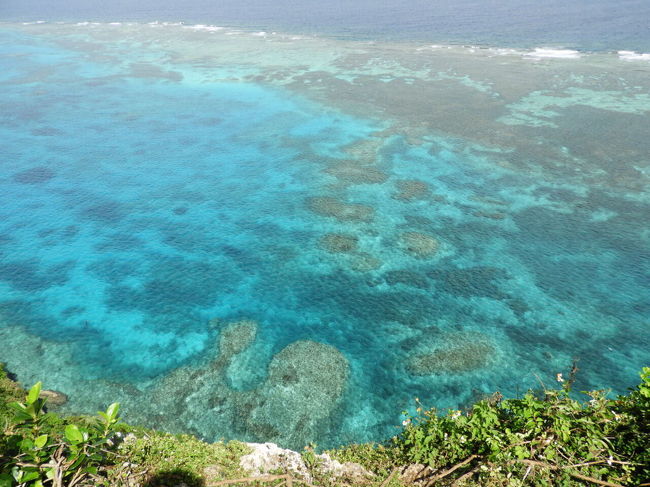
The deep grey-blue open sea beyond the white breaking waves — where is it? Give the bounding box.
[0,0,650,51]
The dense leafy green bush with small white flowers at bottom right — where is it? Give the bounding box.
[394,368,650,485]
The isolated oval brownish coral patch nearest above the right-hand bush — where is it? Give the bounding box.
[407,332,495,375]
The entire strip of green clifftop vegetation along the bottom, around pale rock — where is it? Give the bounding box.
[0,366,650,487]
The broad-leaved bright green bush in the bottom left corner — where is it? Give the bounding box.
[0,382,119,487]
